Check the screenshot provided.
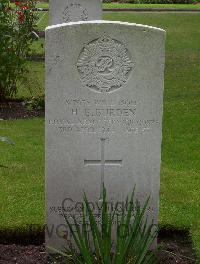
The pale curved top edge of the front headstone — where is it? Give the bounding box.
[45,20,166,34]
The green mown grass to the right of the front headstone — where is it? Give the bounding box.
[108,14,200,263]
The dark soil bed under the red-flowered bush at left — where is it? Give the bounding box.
[0,101,44,120]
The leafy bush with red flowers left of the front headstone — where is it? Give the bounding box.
[0,0,37,100]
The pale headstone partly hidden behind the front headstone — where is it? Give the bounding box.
[49,0,102,25]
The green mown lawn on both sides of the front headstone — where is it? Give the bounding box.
[0,13,200,263]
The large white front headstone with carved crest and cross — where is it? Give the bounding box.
[46,21,165,248]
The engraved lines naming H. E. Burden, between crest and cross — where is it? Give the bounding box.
[48,98,160,135]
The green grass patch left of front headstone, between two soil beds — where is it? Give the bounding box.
[0,119,44,231]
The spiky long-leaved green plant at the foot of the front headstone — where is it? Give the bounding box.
[56,188,158,264]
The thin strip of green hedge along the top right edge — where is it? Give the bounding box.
[103,0,197,4]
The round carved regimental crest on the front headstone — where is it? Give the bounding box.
[77,36,134,93]
